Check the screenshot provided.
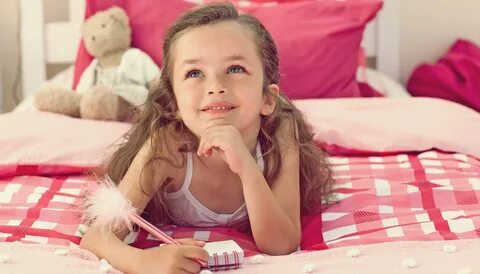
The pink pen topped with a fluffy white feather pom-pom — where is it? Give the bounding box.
[82,177,207,267]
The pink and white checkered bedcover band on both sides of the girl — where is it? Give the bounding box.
[0,151,480,256]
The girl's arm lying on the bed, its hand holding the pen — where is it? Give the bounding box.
[80,142,208,273]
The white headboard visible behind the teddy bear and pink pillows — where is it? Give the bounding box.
[20,0,401,98]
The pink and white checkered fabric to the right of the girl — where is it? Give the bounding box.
[303,151,480,249]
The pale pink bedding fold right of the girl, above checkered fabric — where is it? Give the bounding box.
[294,97,480,158]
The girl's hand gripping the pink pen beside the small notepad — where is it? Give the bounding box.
[135,239,208,274]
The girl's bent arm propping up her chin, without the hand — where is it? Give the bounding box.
[238,120,301,255]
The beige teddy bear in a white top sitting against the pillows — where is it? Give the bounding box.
[34,6,160,121]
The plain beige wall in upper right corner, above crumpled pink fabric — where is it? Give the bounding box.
[400,0,480,82]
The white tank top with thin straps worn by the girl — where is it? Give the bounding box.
[166,143,265,227]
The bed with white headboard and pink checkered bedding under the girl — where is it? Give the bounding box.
[0,0,480,273]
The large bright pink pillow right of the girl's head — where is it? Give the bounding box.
[246,0,383,99]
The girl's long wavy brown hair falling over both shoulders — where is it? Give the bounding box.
[107,3,333,225]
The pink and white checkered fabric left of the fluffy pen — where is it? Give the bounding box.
[0,175,93,245]
